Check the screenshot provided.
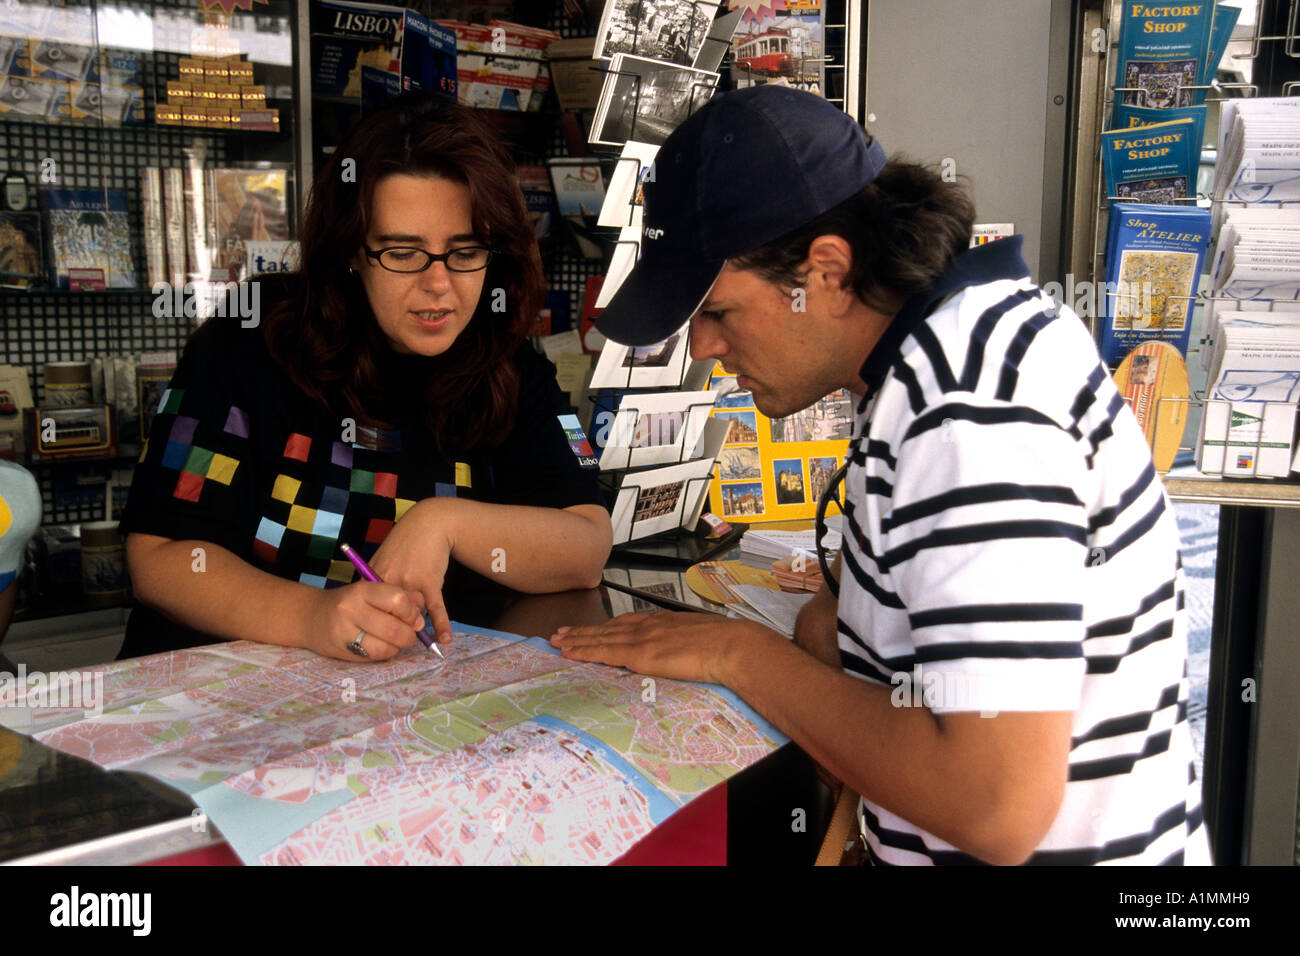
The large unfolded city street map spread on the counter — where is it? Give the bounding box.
[0,627,785,864]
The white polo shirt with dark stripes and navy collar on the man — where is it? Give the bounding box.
[839,237,1209,864]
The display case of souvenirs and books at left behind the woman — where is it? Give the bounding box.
[0,0,309,619]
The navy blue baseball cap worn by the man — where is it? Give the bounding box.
[595,85,885,345]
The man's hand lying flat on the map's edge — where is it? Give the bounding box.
[551,611,785,684]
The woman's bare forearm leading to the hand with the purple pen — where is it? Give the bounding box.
[126,533,320,646]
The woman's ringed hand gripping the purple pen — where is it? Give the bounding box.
[304,581,424,663]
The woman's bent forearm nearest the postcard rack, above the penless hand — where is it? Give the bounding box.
[436,498,614,593]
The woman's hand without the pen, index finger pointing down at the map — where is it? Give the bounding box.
[371,498,455,644]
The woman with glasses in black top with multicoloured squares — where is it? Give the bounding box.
[122,96,611,661]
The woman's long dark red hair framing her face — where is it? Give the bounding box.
[265,94,545,453]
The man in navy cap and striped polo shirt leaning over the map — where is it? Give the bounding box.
[551,86,1209,864]
